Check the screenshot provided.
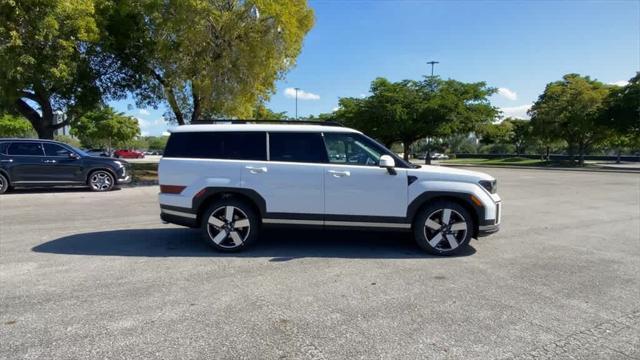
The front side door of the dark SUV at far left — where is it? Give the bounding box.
[42,142,85,182]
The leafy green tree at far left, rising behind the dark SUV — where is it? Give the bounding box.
[0,0,130,139]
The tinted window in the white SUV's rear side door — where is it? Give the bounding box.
[269,132,327,163]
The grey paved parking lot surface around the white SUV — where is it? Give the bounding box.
[0,169,640,359]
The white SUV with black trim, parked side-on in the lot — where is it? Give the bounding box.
[159,121,501,255]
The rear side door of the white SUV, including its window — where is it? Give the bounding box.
[242,132,327,225]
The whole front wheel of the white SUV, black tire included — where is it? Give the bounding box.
[413,201,475,256]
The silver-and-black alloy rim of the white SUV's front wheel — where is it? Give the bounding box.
[424,208,468,251]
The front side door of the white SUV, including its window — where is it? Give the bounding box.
[324,133,408,221]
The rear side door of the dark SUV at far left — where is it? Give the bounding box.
[3,141,50,183]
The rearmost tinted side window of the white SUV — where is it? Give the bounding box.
[164,131,267,160]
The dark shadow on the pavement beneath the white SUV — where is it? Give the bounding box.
[32,228,476,261]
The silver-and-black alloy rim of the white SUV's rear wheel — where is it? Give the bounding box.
[207,205,251,249]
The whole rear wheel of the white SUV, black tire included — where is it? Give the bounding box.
[201,197,260,252]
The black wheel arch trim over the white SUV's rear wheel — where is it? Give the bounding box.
[192,187,266,226]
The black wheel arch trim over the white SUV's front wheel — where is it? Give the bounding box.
[407,191,484,238]
